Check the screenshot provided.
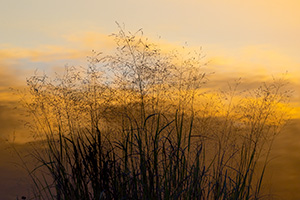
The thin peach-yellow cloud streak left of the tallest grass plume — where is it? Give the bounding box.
[0,32,178,63]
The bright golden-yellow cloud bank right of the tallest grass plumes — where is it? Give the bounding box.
[209,46,300,83]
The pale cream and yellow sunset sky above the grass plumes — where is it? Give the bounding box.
[0,0,300,199]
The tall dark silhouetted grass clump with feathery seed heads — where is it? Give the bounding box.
[21,28,288,200]
